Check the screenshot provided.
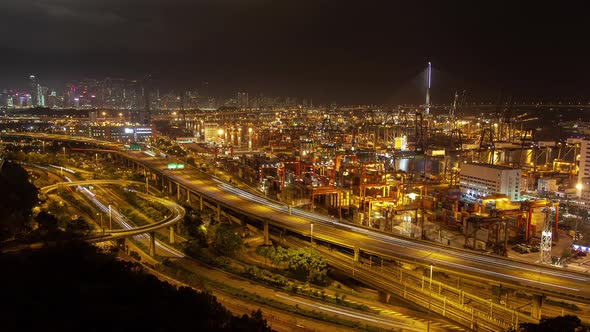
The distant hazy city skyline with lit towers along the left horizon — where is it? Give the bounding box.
[0,75,320,110]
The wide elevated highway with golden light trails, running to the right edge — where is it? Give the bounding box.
[4,134,590,326]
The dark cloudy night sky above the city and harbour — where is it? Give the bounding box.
[0,0,590,104]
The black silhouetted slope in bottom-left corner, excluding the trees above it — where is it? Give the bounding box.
[0,241,270,331]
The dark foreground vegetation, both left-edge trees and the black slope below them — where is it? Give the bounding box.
[0,162,270,331]
